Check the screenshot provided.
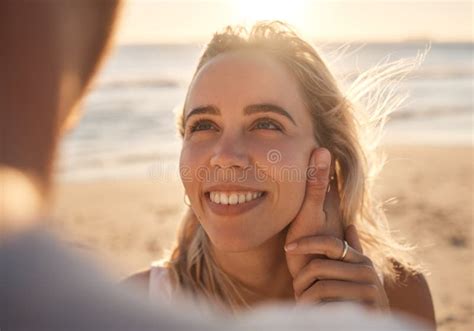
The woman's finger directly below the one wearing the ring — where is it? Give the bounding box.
[293,259,377,297]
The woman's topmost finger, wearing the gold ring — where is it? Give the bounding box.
[285,236,371,264]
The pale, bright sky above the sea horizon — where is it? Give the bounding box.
[118,0,474,44]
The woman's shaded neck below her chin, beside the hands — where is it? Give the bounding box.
[212,231,293,304]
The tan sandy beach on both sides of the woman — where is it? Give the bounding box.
[52,146,474,331]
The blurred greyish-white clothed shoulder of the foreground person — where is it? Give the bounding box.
[0,228,425,331]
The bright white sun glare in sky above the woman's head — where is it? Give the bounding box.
[233,0,307,26]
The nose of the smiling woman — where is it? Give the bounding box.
[210,137,250,169]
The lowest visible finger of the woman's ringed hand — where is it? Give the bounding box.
[297,280,379,303]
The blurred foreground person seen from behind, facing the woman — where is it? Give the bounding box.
[0,0,426,330]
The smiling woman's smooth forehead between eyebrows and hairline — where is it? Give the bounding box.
[185,51,304,113]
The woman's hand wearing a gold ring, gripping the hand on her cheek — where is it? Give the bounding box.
[286,225,389,311]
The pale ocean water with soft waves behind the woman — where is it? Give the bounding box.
[57,43,474,180]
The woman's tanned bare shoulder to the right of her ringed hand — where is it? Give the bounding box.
[384,263,436,329]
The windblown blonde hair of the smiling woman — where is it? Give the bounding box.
[167,21,421,310]
